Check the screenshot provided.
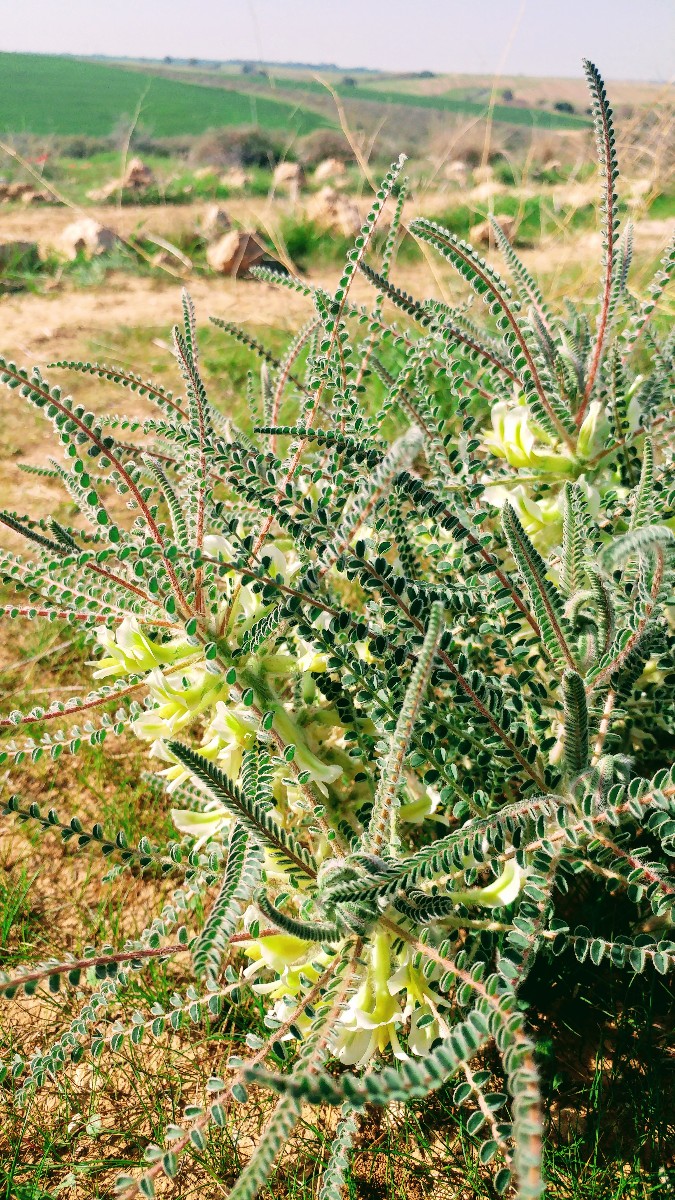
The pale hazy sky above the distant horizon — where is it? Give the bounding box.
[0,0,675,80]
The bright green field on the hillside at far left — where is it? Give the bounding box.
[0,54,329,137]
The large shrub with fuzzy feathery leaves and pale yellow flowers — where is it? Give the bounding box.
[0,65,675,1200]
